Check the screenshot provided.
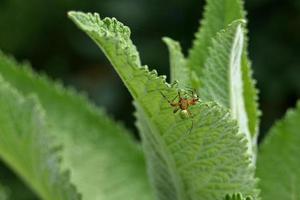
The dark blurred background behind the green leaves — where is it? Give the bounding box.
[0,0,300,199]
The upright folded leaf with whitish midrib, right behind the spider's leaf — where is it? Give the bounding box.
[200,20,255,159]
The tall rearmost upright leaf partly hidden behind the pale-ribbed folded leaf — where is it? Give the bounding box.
[187,0,260,144]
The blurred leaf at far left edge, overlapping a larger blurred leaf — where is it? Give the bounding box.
[0,77,80,200]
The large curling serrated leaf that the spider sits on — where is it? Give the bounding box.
[69,12,257,200]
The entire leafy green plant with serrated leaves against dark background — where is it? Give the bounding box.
[0,0,300,200]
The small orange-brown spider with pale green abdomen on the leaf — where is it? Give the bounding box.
[160,90,200,133]
